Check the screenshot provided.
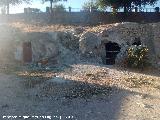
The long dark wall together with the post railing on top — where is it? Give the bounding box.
[0,7,160,24]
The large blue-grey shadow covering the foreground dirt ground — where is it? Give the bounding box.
[0,61,159,120]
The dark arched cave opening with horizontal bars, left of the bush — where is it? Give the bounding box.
[105,42,121,65]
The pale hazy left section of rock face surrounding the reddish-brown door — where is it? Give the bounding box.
[0,25,58,63]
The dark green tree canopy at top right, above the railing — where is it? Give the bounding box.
[97,0,158,12]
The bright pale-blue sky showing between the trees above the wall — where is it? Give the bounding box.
[10,0,160,13]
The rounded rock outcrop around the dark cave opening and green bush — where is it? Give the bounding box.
[99,23,158,62]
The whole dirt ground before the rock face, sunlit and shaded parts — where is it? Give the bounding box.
[0,64,160,120]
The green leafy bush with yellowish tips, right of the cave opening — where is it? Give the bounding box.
[126,45,149,69]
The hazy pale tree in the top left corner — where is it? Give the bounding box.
[0,0,31,14]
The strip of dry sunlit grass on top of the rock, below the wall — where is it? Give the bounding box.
[10,22,113,33]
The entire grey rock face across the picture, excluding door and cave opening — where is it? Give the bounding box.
[0,23,160,64]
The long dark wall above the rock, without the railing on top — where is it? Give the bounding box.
[0,12,160,24]
